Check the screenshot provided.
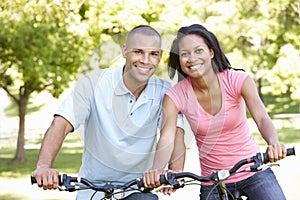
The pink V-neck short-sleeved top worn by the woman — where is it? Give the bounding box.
[166,69,260,184]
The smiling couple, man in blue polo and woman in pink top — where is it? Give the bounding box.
[33,24,286,200]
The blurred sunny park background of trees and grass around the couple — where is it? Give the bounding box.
[0,0,300,199]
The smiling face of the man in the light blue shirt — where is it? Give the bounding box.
[122,34,162,84]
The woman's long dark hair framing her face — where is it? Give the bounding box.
[168,24,237,81]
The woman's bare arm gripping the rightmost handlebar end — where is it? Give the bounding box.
[242,77,286,162]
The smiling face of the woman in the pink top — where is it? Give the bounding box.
[178,34,214,78]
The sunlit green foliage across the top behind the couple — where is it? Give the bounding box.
[0,0,300,162]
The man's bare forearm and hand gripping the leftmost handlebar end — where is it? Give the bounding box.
[33,116,73,190]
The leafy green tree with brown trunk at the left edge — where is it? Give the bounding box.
[0,0,85,162]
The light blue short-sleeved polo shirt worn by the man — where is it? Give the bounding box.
[56,67,182,199]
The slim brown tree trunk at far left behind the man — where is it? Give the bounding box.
[11,95,28,163]
